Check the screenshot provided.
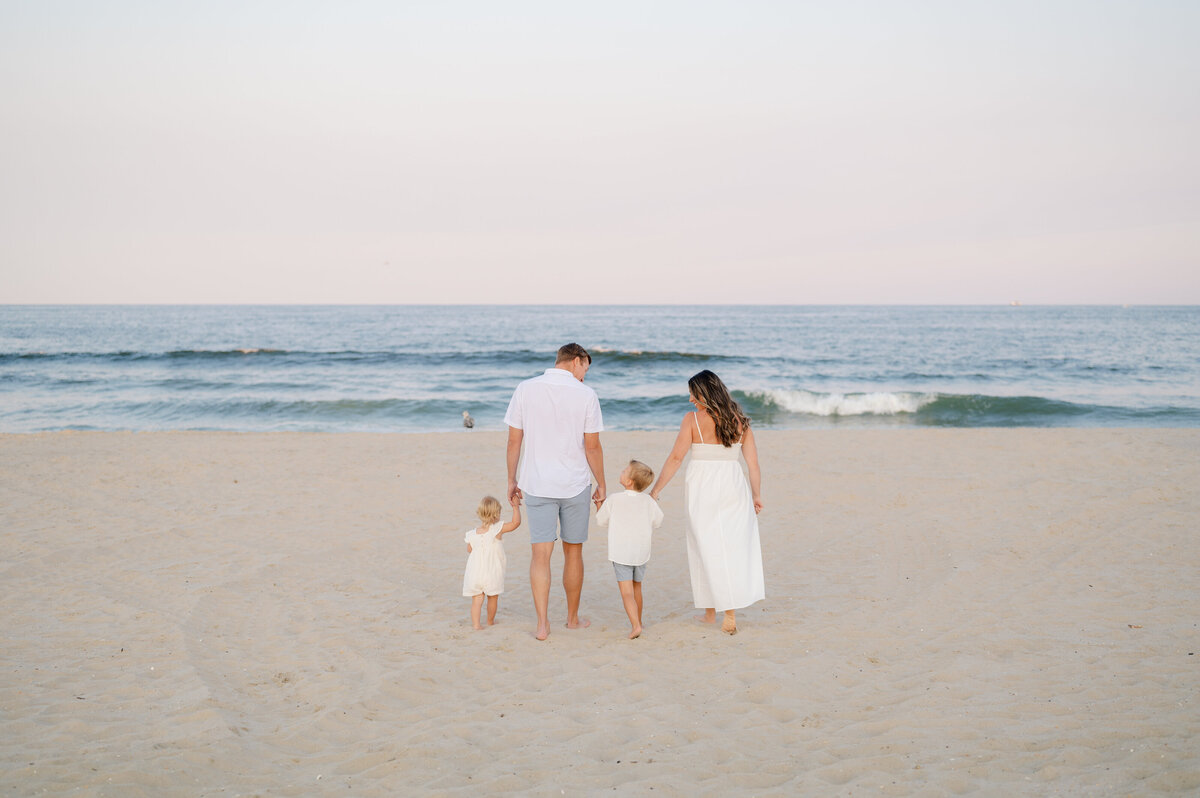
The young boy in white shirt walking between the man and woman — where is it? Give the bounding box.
[596,460,662,640]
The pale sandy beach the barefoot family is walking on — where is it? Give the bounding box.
[0,428,1200,797]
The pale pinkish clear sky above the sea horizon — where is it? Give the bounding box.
[0,0,1200,304]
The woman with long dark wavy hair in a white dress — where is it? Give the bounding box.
[650,370,766,635]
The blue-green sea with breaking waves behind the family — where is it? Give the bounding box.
[0,306,1200,432]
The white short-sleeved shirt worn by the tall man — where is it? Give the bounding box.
[504,368,604,499]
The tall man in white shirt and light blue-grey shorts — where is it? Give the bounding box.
[504,343,606,640]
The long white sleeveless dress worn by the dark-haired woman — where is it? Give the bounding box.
[683,421,767,612]
